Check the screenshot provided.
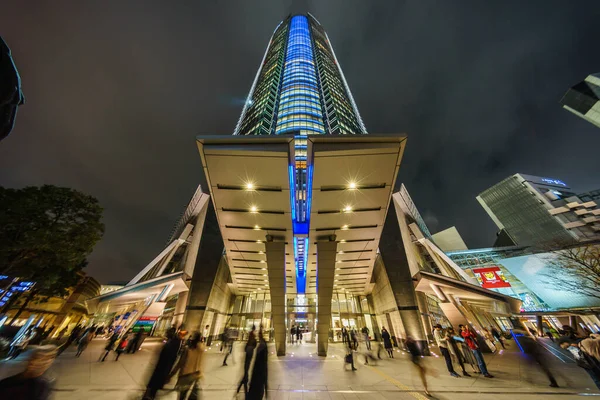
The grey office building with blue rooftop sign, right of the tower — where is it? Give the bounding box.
[477,174,600,246]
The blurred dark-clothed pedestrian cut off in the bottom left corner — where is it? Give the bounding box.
[0,345,57,400]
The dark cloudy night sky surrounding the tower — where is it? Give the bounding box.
[0,0,600,282]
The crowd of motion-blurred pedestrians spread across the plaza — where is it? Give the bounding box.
[0,318,600,400]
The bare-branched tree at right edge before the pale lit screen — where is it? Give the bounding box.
[543,243,600,300]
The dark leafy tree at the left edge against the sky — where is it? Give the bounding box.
[0,185,104,320]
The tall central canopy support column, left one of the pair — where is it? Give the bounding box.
[265,237,287,356]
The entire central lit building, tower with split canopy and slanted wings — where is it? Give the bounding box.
[88,15,519,356]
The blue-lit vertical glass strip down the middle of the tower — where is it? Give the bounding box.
[275,15,325,294]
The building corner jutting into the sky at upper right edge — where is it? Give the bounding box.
[560,74,600,127]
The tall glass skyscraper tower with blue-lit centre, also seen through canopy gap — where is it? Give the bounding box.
[234,14,367,293]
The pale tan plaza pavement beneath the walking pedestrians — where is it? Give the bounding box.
[0,338,600,400]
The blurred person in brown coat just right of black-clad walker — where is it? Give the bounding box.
[167,332,206,400]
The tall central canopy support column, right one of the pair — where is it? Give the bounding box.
[317,236,337,357]
